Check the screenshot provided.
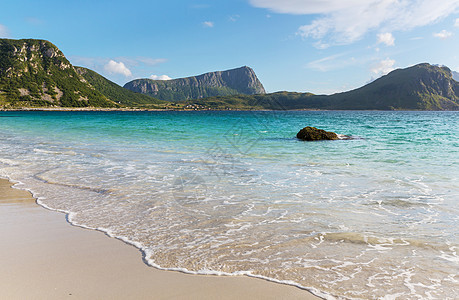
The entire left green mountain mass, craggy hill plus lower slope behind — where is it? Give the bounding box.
[0,39,169,109]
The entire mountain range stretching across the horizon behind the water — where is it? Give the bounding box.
[0,39,459,110]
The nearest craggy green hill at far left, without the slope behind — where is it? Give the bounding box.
[0,39,118,108]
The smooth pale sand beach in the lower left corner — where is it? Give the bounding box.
[0,179,319,299]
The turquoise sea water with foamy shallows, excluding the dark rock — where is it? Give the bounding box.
[0,111,459,299]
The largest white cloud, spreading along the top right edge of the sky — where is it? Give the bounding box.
[249,0,459,45]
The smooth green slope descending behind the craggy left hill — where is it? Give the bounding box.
[75,67,168,107]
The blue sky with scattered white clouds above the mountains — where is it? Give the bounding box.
[0,0,459,94]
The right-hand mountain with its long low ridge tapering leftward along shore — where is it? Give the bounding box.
[193,63,459,110]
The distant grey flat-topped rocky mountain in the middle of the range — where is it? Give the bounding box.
[124,67,266,101]
